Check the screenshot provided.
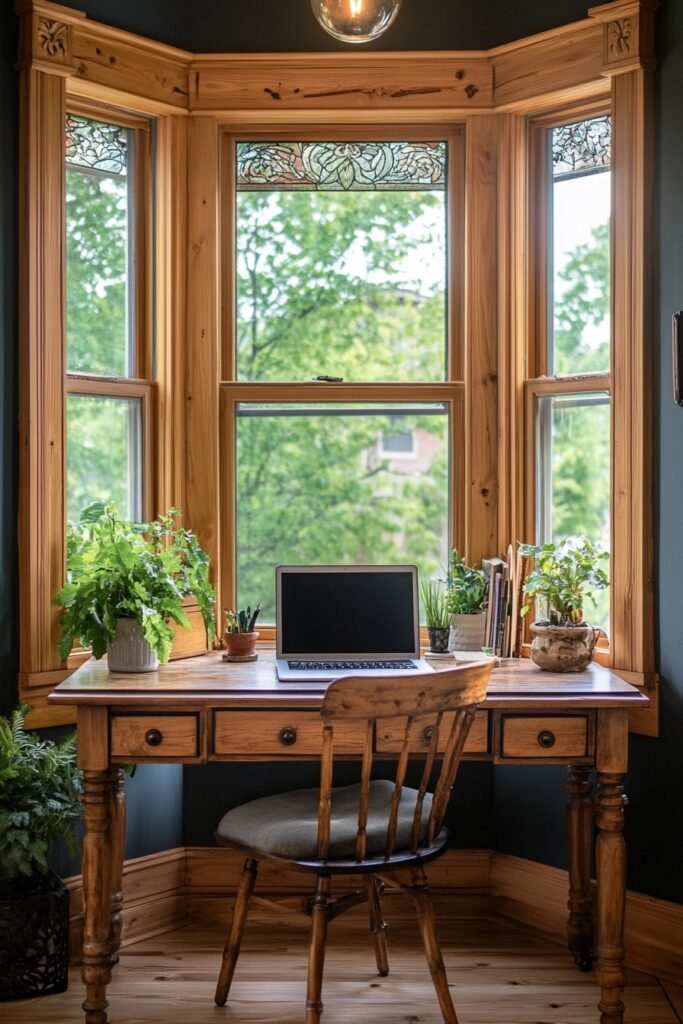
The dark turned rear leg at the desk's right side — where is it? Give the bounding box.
[566,765,593,971]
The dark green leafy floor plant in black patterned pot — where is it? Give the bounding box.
[0,706,81,1001]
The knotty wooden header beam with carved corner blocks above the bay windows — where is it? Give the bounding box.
[15,0,656,120]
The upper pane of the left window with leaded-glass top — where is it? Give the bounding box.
[66,114,135,377]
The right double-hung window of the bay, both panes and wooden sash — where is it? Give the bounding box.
[527,113,612,631]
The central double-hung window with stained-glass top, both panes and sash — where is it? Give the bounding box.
[223,132,463,623]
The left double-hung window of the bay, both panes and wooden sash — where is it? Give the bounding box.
[65,110,151,520]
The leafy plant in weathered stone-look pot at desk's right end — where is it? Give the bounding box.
[519,537,608,672]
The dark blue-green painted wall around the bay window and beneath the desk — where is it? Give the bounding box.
[0,0,683,902]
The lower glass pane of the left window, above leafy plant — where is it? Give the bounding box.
[67,394,142,520]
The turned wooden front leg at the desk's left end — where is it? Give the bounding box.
[82,769,113,1024]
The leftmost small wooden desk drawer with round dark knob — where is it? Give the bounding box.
[111,715,199,760]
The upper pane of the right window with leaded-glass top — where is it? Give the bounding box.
[547,116,611,376]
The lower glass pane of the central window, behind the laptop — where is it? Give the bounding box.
[236,401,451,623]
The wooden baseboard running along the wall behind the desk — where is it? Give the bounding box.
[63,847,683,986]
